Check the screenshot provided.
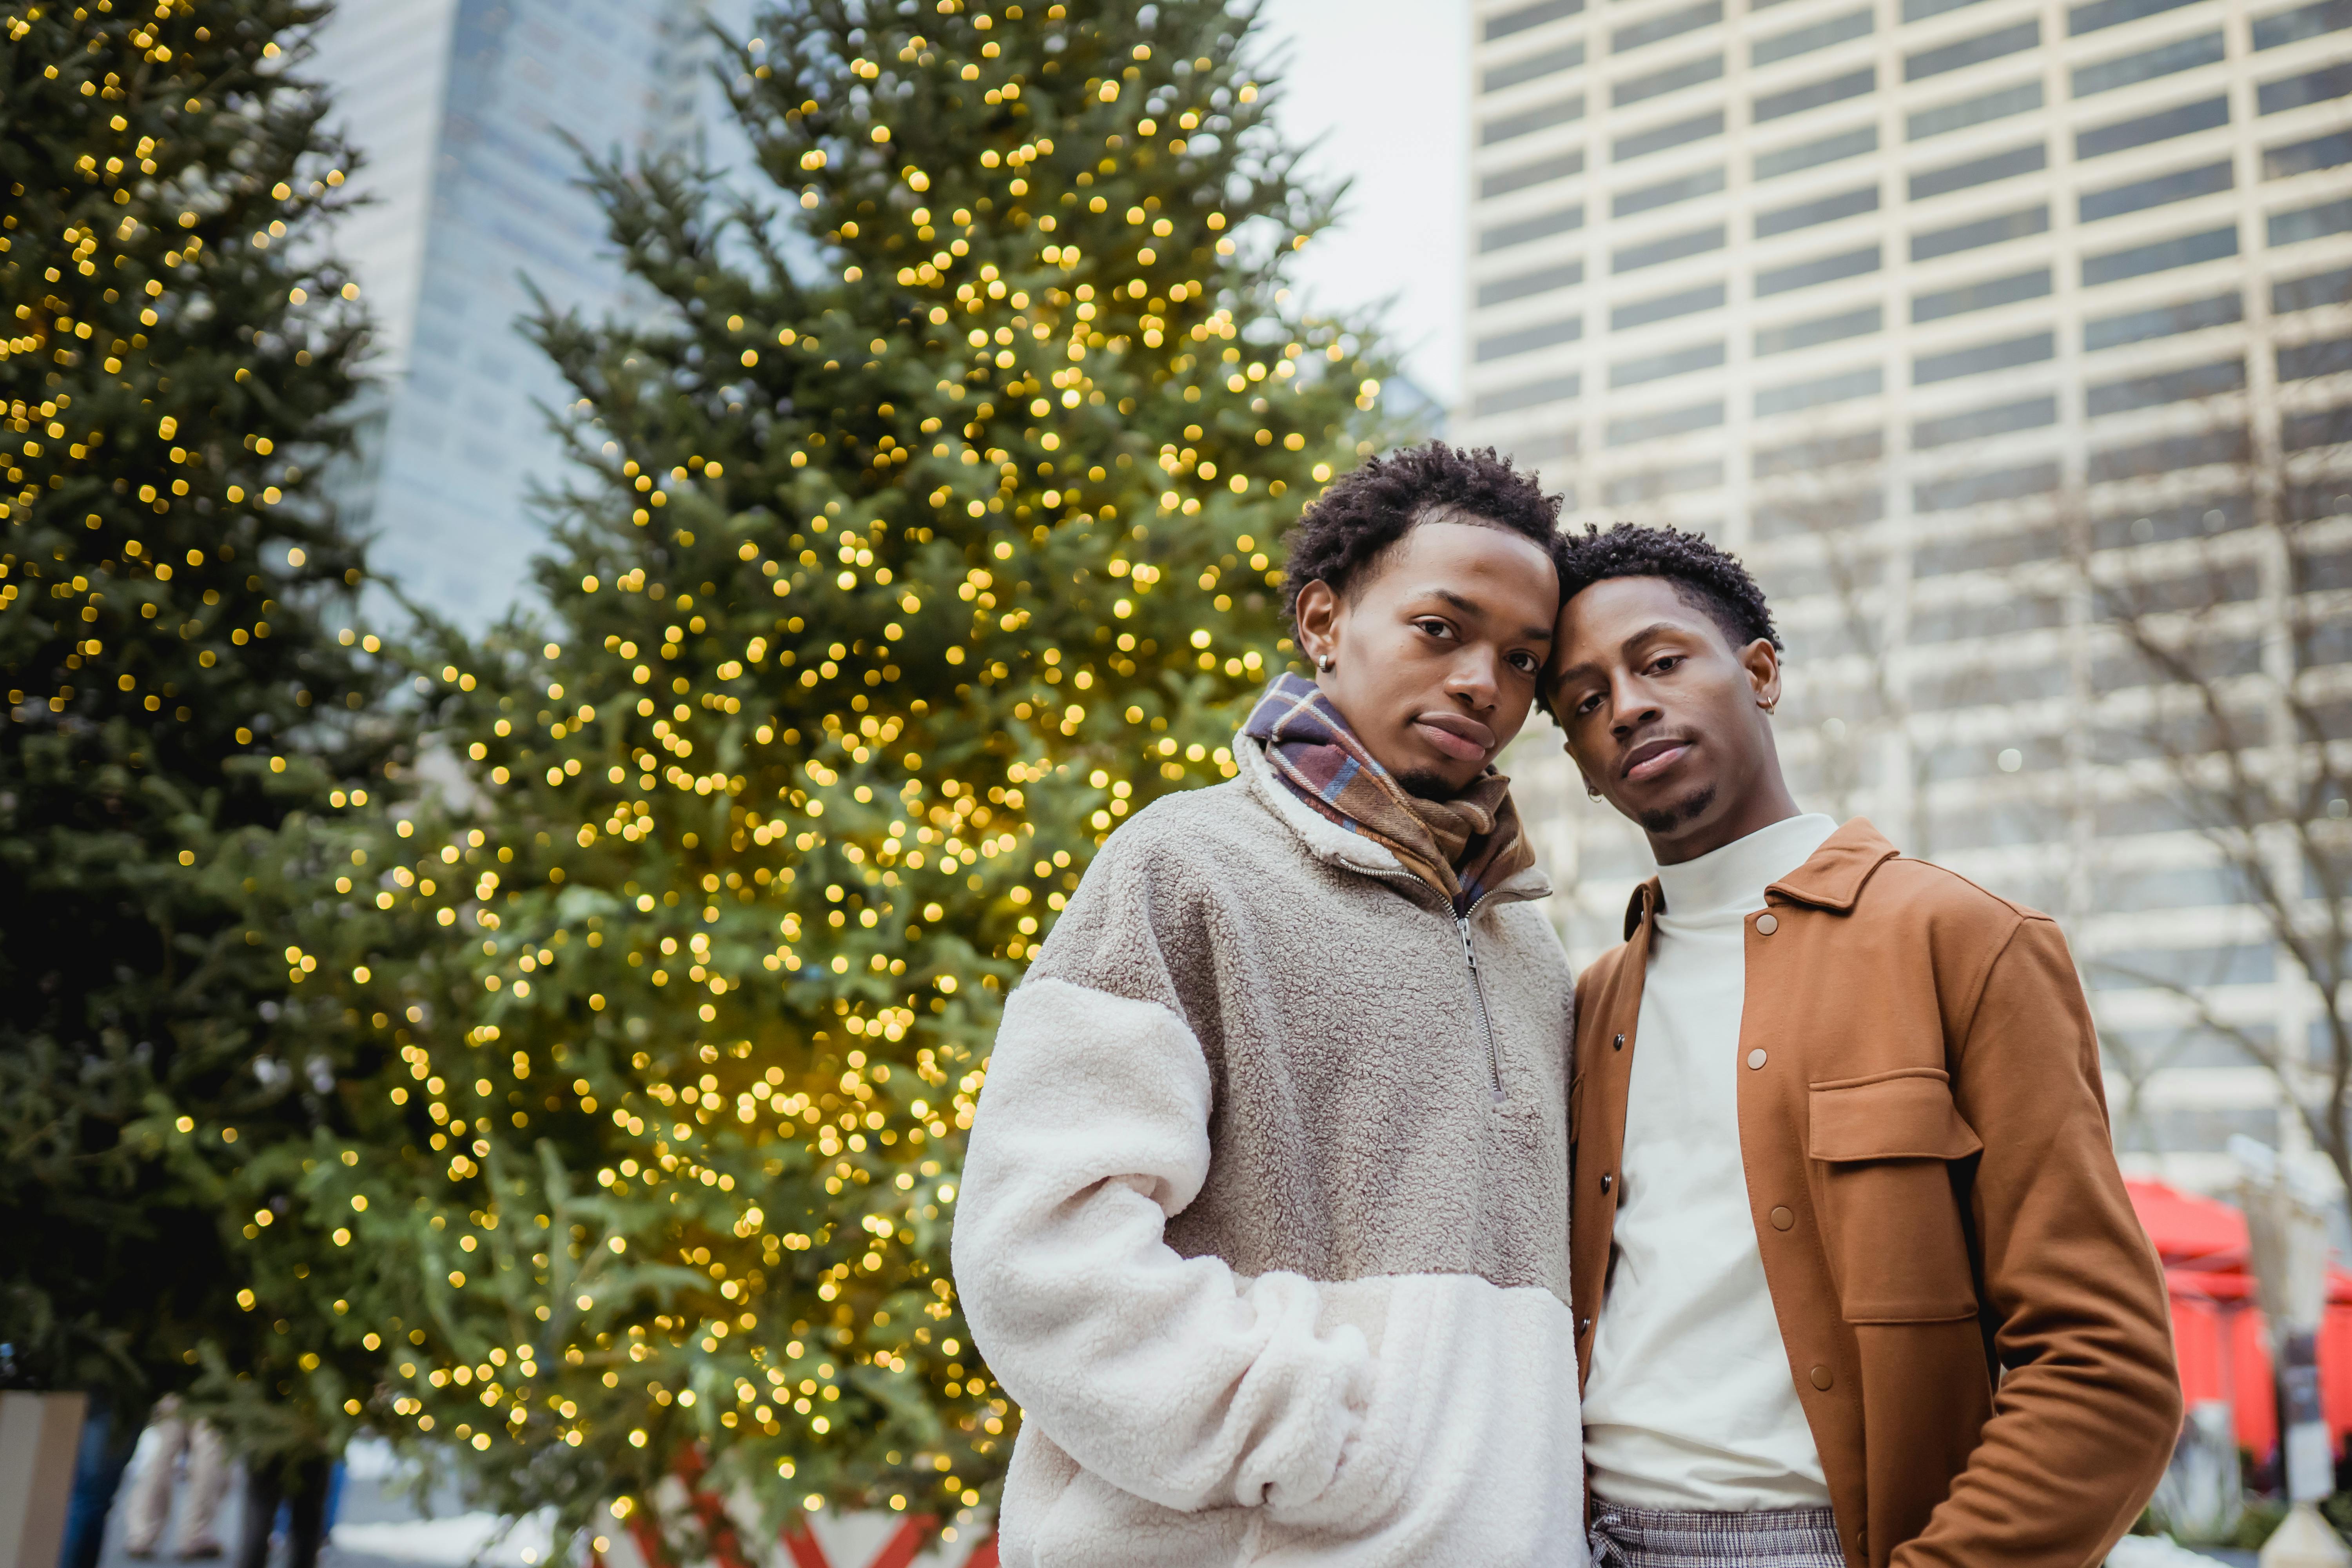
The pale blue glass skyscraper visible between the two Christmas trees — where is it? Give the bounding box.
[310,0,713,623]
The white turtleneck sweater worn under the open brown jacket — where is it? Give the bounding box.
[1585,816,1837,1512]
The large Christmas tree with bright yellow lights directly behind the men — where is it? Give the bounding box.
[273,0,1381,1556]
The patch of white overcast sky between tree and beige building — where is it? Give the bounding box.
[1265,0,1470,407]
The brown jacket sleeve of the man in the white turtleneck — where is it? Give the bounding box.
[1891,917,2180,1568]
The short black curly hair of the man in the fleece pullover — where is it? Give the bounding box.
[1284,442,1559,628]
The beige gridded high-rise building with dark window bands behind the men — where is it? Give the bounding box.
[1458,0,2352,1178]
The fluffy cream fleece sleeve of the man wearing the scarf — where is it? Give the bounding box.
[955,978,1376,1514]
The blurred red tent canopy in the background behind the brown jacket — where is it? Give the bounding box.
[2124,1182,2352,1457]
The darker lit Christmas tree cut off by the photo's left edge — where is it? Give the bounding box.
[0,0,390,1439]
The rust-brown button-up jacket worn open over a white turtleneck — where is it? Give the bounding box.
[1569,818,2180,1568]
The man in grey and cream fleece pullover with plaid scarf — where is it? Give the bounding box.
[955,444,1585,1568]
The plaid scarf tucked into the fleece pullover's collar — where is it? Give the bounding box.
[1242,675,1536,915]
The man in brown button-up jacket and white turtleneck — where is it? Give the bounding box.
[1548,524,2180,1568]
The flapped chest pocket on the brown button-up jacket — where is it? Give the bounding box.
[1806,1067,1985,1323]
